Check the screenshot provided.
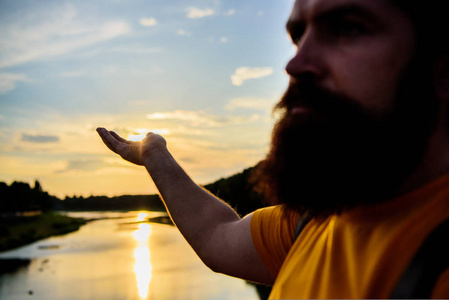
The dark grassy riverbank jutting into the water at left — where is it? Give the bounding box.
[0,212,87,252]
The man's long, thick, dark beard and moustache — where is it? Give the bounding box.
[258,63,437,216]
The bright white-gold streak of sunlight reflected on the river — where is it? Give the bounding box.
[133,213,152,299]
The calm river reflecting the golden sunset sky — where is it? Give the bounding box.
[0,212,258,300]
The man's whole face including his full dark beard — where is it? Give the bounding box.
[263,0,434,214]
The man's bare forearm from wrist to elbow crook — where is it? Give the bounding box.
[144,147,240,260]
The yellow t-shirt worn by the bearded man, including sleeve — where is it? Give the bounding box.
[251,175,449,299]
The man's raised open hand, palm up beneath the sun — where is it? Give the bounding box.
[97,127,166,166]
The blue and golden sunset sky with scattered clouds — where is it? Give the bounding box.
[0,0,294,198]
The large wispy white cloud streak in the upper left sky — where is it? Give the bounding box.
[0,5,131,68]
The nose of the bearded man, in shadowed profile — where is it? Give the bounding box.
[285,31,325,79]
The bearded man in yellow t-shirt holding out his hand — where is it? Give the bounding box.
[97,0,449,299]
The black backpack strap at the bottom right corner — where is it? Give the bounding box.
[390,219,449,299]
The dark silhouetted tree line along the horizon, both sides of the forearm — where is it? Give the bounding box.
[0,167,265,216]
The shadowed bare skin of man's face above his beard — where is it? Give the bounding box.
[286,0,415,114]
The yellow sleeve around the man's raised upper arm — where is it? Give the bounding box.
[251,205,299,278]
